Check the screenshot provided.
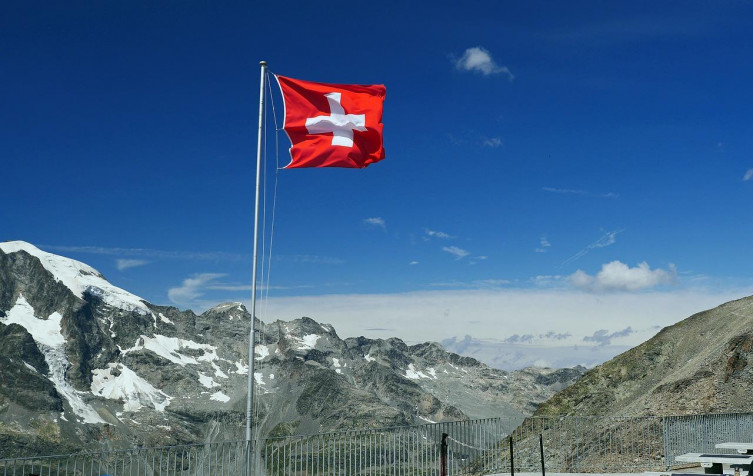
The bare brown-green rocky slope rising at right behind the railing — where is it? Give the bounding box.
[536,297,753,415]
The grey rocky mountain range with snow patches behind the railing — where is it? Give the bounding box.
[0,241,584,458]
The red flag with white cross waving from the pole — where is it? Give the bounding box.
[275,75,387,169]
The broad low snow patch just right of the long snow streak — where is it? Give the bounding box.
[91,363,173,412]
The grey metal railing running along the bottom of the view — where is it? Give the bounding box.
[5,413,753,476]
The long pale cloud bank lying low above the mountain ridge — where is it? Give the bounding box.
[260,284,753,353]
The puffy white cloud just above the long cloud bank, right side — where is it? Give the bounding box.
[568,261,677,292]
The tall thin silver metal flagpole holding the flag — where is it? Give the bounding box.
[246,61,267,443]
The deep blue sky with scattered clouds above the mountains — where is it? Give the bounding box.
[0,1,753,368]
